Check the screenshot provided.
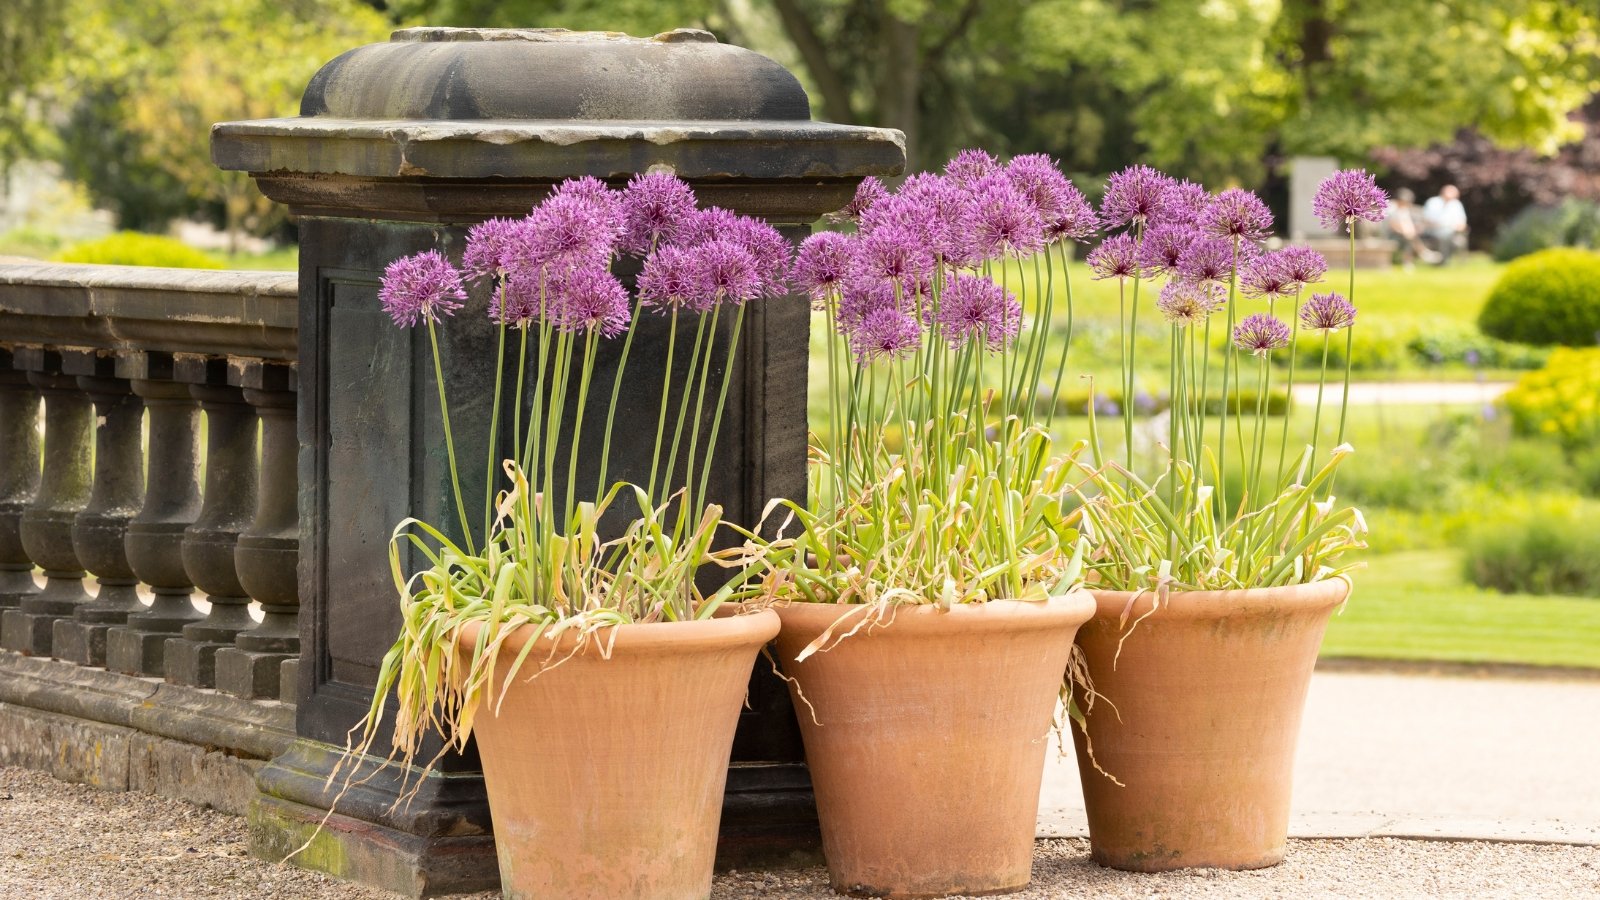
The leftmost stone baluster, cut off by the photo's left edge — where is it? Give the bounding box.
[0,349,40,610]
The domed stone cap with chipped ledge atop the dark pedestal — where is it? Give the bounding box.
[211,27,906,221]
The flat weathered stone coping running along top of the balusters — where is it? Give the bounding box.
[0,263,299,362]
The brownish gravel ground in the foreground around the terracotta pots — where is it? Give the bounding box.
[0,769,1600,900]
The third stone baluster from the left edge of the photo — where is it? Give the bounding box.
[53,360,144,666]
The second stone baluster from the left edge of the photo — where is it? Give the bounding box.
[0,351,94,657]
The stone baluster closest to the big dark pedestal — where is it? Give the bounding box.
[216,364,299,703]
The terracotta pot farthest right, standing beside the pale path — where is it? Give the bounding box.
[1072,578,1349,871]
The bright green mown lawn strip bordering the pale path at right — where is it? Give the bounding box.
[1322,549,1600,668]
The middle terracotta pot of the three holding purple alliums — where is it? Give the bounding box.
[776,593,1094,897]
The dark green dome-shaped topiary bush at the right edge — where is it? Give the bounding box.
[1478,248,1600,348]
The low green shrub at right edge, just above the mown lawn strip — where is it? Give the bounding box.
[1466,498,1600,597]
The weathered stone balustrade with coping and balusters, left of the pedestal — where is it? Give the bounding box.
[0,263,299,703]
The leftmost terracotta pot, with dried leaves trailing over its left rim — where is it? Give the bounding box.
[461,612,778,900]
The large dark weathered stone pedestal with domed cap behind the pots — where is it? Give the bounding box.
[213,29,904,895]
